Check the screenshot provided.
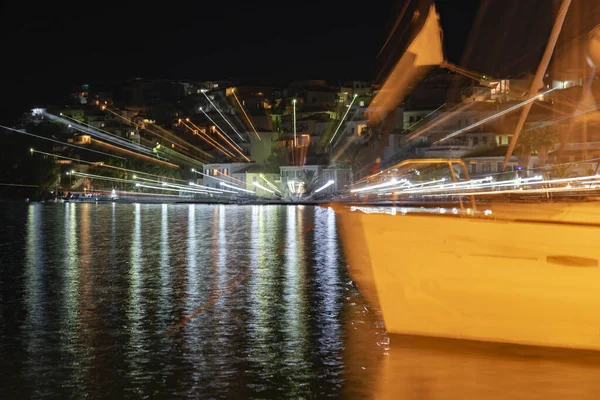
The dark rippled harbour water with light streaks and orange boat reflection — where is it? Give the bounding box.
[0,203,600,399]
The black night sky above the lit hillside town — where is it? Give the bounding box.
[0,0,479,121]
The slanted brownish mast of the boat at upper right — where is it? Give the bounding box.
[502,0,571,171]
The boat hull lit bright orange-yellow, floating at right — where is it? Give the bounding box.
[336,204,600,350]
